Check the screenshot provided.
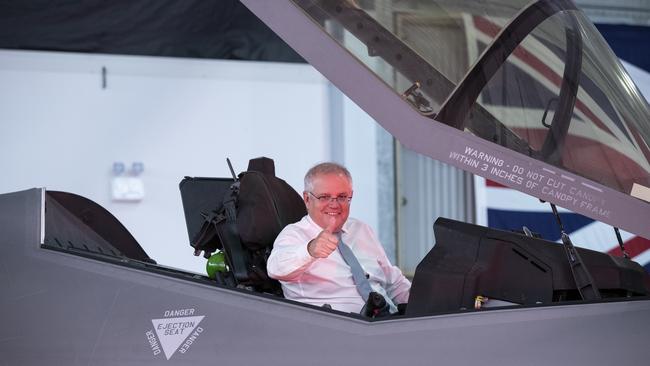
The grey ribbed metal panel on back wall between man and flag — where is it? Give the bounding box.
[394,8,474,275]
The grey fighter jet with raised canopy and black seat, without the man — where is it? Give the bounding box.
[0,0,650,365]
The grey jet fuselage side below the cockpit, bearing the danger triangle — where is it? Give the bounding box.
[0,190,650,366]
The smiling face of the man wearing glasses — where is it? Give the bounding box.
[303,173,352,232]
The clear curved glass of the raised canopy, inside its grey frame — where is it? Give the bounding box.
[293,0,650,194]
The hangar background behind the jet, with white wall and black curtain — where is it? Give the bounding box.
[0,0,650,274]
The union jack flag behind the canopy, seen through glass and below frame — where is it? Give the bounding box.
[465,16,650,272]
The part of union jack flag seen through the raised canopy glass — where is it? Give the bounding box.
[466,16,650,193]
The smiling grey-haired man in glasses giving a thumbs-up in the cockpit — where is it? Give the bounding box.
[267,163,411,313]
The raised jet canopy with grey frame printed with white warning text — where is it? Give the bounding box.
[242,0,650,238]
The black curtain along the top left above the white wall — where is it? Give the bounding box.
[0,0,304,62]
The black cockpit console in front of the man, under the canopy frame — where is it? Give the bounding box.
[406,218,650,316]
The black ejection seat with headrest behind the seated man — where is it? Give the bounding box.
[180,157,307,296]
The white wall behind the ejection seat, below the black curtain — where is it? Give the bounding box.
[0,51,318,272]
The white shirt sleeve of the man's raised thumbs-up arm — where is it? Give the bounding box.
[266,225,316,281]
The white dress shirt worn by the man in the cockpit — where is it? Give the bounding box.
[267,215,411,313]
